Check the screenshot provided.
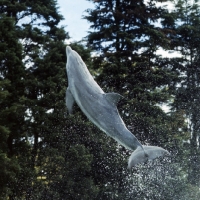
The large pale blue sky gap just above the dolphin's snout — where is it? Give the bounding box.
[57,0,94,41]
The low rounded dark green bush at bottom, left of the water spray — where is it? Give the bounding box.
[60,145,98,199]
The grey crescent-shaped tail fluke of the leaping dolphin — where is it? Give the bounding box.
[128,146,170,170]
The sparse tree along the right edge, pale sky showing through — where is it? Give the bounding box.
[170,1,200,185]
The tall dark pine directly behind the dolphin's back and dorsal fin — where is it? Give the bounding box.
[85,0,176,144]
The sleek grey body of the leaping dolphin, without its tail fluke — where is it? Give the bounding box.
[66,46,169,166]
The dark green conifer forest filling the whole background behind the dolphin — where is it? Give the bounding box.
[0,0,200,200]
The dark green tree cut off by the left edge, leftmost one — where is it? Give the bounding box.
[0,14,26,199]
